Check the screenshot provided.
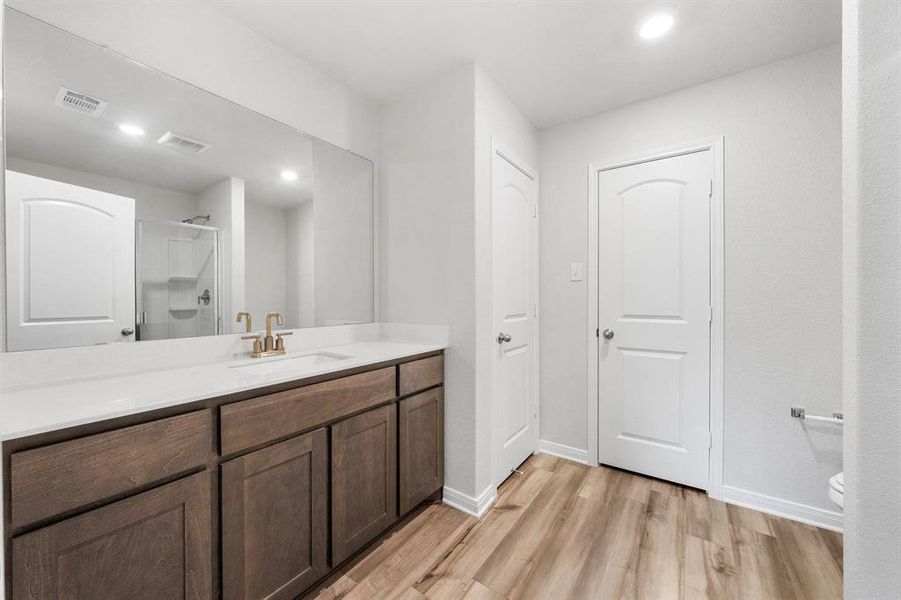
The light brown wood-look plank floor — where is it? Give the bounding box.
[308,454,842,600]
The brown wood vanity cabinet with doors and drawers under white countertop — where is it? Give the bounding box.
[2,343,444,600]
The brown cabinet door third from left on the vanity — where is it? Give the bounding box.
[332,404,397,565]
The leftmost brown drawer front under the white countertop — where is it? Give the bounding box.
[10,410,213,528]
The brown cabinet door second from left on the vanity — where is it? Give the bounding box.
[222,429,328,600]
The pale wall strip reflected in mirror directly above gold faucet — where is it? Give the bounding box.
[244,202,286,330]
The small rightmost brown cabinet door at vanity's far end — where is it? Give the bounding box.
[398,388,444,515]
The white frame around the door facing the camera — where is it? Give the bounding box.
[586,135,725,498]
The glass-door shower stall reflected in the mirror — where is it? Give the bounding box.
[136,221,219,340]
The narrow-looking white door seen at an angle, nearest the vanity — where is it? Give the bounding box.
[492,152,538,484]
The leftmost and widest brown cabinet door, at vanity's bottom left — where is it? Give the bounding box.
[12,472,212,600]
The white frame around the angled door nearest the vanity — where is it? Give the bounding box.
[486,137,541,487]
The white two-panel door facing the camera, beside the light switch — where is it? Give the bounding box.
[598,151,713,488]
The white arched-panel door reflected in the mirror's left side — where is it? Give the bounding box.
[6,171,135,350]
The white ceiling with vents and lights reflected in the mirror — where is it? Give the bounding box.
[4,5,352,208]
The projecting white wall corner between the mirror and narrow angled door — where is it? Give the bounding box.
[379,64,538,498]
